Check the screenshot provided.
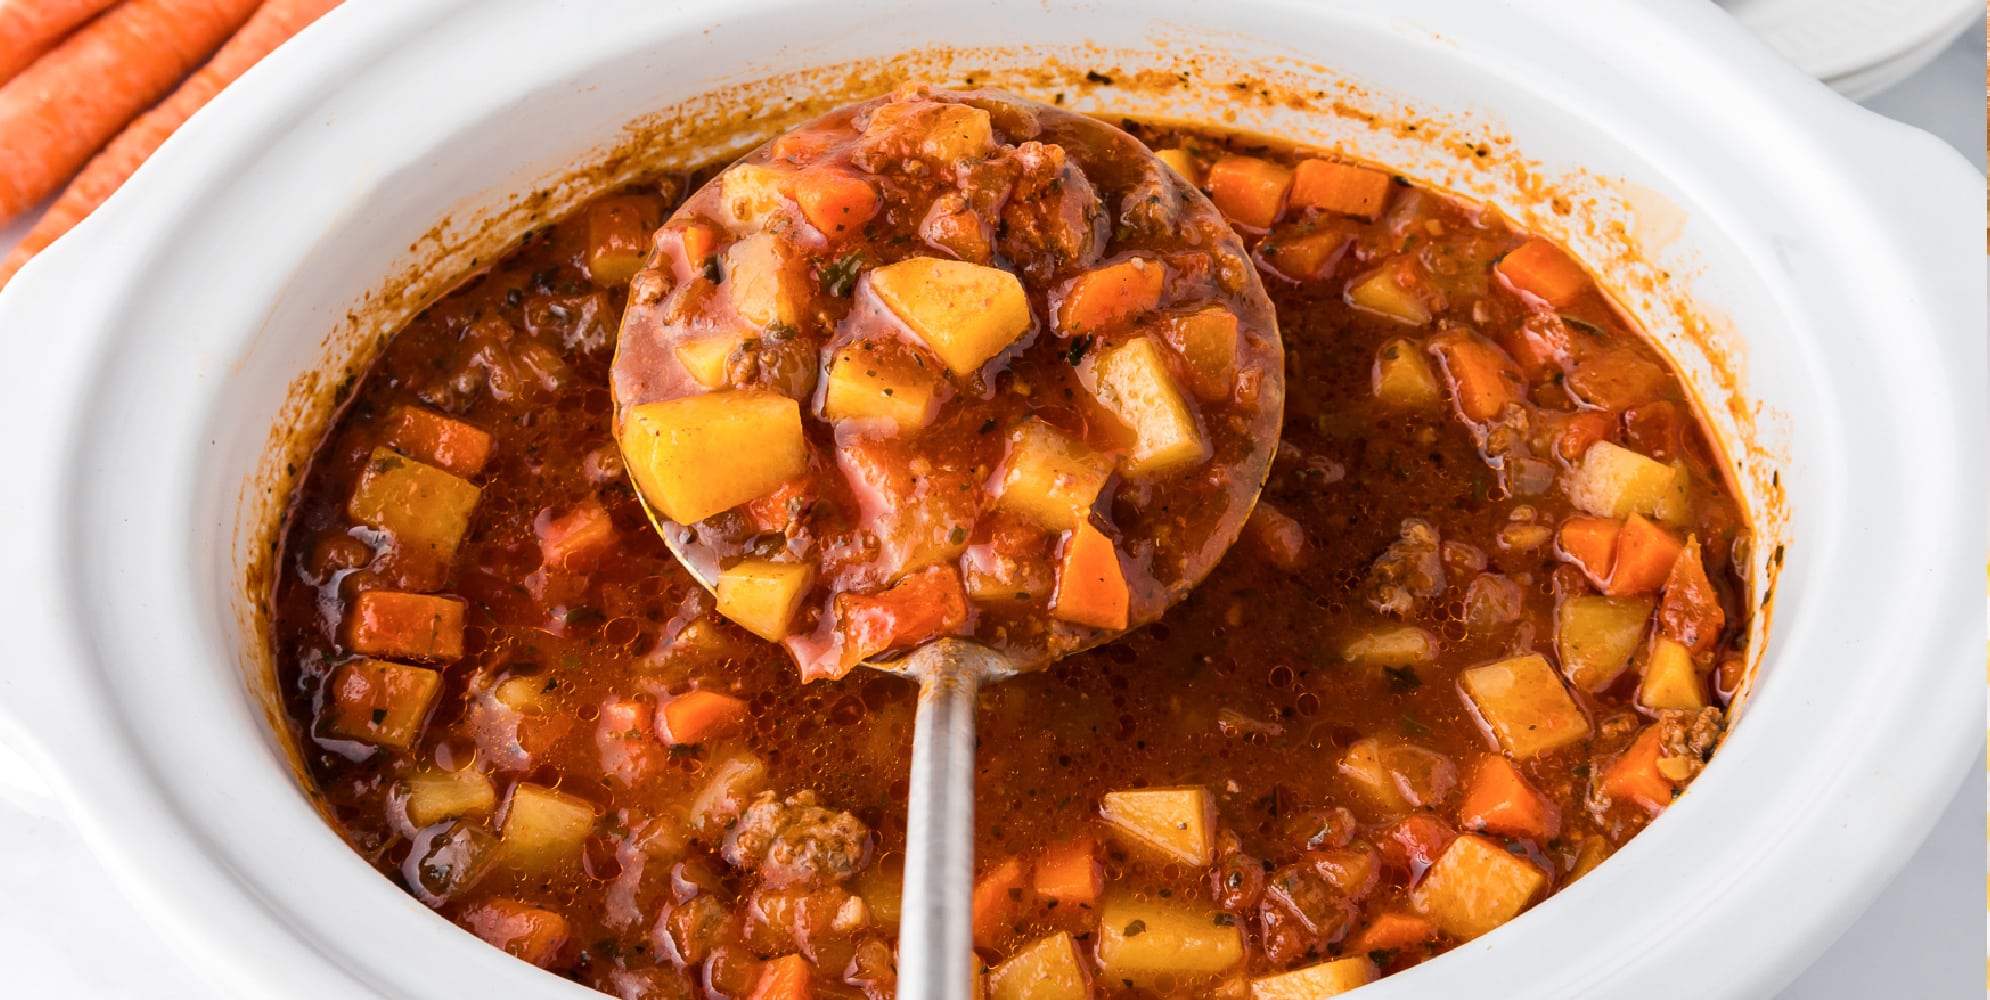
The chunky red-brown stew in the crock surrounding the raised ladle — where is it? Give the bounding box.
[275,105,1747,1000]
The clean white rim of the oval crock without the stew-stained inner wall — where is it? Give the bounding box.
[0,0,1990,1000]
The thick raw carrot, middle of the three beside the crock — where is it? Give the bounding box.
[0,0,257,223]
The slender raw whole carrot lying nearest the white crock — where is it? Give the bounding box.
[0,0,340,284]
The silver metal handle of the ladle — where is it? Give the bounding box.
[897,640,1007,1000]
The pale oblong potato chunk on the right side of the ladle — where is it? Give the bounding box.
[1081,338,1210,475]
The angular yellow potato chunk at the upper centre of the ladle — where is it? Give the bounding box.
[870,256,1031,376]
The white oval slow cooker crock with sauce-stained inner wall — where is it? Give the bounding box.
[0,0,1990,1000]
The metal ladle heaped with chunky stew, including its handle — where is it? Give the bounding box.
[613,87,1284,998]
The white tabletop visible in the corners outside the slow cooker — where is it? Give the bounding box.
[0,3,1984,1000]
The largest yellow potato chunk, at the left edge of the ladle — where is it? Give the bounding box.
[621,390,808,525]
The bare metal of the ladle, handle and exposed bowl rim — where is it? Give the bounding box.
[617,91,1284,1000]
